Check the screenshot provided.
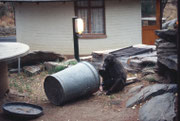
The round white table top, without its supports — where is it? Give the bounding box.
[0,42,29,62]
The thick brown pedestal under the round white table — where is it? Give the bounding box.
[0,62,9,98]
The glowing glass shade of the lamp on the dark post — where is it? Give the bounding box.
[75,18,84,34]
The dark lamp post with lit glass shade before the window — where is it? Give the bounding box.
[72,17,84,62]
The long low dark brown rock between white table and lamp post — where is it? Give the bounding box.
[8,51,65,68]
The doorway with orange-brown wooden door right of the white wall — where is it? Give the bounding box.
[141,0,160,45]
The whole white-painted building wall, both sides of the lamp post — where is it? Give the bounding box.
[16,0,141,55]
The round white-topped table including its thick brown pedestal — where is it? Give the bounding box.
[0,42,29,98]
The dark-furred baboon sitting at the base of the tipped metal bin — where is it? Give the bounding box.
[99,55,127,95]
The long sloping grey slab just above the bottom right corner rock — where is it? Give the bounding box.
[126,84,177,107]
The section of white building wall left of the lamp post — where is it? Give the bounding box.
[15,2,74,54]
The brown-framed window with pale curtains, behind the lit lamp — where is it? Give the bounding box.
[75,0,106,38]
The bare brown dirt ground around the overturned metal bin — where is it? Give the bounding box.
[0,72,149,121]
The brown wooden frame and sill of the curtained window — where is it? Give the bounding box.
[74,0,107,39]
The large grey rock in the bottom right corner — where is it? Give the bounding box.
[139,93,176,121]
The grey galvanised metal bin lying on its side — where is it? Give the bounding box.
[44,61,100,105]
